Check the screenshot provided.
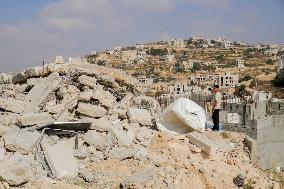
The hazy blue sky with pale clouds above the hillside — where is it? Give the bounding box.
[0,0,284,73]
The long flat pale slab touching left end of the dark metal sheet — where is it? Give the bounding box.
[19,112,55,127]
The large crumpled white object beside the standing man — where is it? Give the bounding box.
[157,98,206,134]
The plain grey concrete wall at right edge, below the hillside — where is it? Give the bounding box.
[257,115,284,168]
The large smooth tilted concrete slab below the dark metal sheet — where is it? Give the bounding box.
[44,140,79,179]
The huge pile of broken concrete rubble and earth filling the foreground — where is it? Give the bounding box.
[0,63,276,188]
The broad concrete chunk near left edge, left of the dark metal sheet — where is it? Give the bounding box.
[3,129,41,154]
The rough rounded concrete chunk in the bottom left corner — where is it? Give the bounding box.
[0,153,34,186]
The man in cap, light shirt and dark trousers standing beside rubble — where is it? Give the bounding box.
[212,85,222,131]
